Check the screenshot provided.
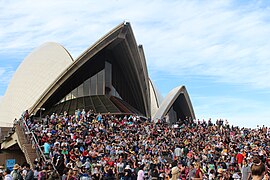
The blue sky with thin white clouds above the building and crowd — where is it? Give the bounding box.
[0,0,270,127]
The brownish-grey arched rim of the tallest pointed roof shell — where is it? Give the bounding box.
[32,22,153,115]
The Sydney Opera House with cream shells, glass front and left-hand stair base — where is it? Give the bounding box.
[0,22,195,166]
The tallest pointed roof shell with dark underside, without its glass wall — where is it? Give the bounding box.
[31,23,150,116]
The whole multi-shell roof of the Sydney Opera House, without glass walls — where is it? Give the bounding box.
[0,22,195,126]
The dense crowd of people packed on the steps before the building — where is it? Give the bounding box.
[4,110,270,180]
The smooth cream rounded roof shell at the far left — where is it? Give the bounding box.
[0,42,73,126]
